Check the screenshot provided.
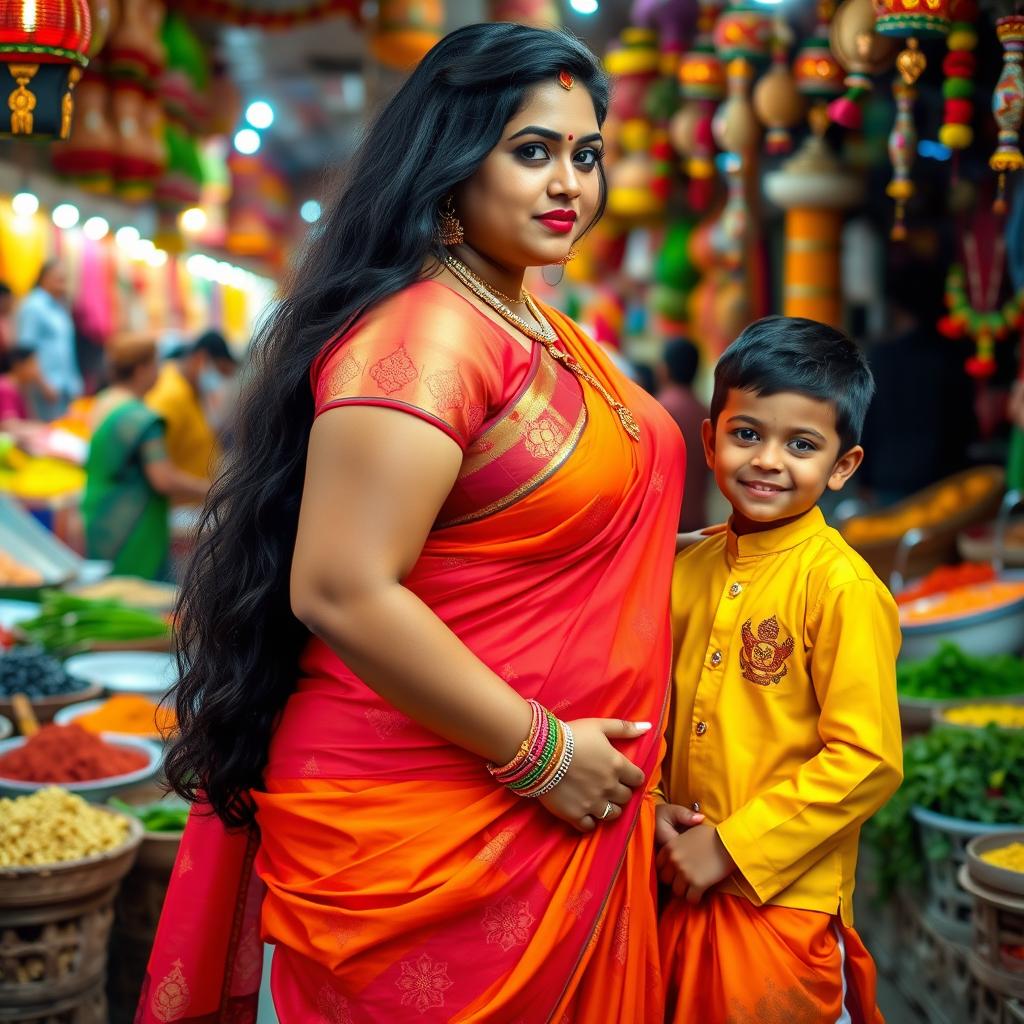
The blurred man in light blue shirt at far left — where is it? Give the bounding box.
[14,260,82,420]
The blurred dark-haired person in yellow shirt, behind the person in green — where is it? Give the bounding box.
[145,331,236,477]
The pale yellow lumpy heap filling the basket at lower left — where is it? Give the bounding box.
[0,787,128,867]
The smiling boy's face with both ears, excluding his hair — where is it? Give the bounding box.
[702,388,863,534]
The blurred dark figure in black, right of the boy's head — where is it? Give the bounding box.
[861,263,977,505]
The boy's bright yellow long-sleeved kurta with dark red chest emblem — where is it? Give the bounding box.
[663,508,902,1020]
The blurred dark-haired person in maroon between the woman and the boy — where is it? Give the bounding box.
[657,338,711,532]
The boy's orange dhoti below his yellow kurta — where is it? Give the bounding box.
[659,893,885,1024]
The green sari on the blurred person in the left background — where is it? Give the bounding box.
[82,399,170,580]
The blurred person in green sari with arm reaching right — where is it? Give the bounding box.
[82,334,208,580]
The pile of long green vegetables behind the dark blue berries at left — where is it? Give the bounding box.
[18,591,170,652]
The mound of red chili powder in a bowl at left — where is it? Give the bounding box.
[0,723,146,782]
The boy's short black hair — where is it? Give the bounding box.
[711,316,874,455]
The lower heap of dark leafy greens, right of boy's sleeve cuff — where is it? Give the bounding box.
[864,726,1024,897]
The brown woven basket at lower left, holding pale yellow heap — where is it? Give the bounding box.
[0,811,142,1011]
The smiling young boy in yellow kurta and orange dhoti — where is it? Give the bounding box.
[657,317,902,1024]
